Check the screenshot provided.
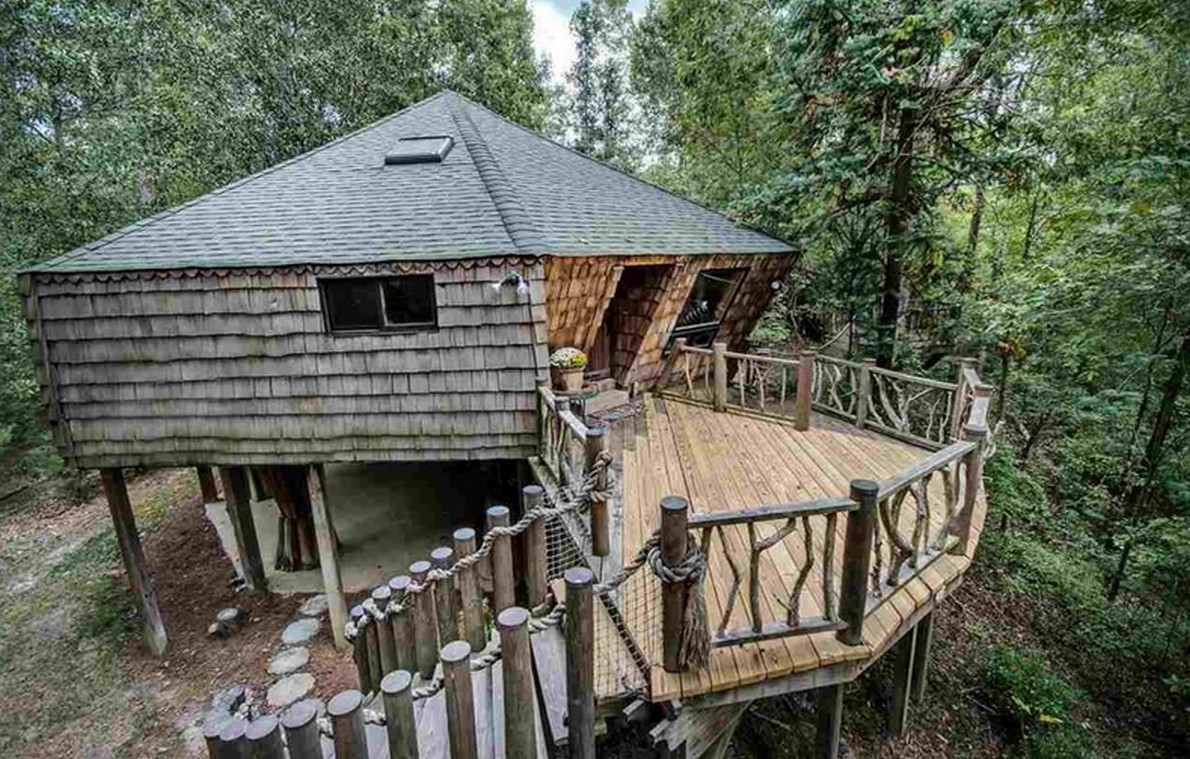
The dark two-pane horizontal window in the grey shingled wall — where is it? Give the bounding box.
[319,274,438,332]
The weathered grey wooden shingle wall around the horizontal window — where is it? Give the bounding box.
[26,259,547,466]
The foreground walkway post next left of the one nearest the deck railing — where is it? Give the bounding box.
[496,607,537,759]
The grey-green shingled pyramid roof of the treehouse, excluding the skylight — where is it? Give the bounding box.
[30,92,791,272]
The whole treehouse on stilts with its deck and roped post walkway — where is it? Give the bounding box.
[20,93,988,759]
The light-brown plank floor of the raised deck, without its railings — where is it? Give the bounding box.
[596,396,983,701]
